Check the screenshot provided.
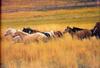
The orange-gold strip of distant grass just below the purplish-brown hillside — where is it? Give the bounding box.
[2,7,100,19]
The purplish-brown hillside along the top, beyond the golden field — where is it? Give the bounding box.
[2,0,100,12]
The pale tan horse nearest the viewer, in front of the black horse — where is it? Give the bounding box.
[15,32,48,43]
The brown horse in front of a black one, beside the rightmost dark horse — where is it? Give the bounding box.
[64,27,92,40]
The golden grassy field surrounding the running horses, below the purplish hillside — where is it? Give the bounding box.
[1,7,100,68]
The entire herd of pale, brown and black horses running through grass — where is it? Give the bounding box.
[4,22,100,43]
